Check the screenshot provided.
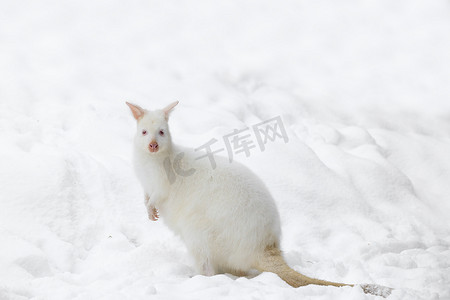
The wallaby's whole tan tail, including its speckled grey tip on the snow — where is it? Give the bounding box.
[256,246,392,297]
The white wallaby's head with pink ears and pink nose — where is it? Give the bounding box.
[126,101,178,155]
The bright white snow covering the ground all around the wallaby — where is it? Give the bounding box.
[0,0,450,300]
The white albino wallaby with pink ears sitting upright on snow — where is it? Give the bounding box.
[126,101,390,296]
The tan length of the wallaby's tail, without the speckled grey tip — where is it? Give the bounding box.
[257,247,353,287]
